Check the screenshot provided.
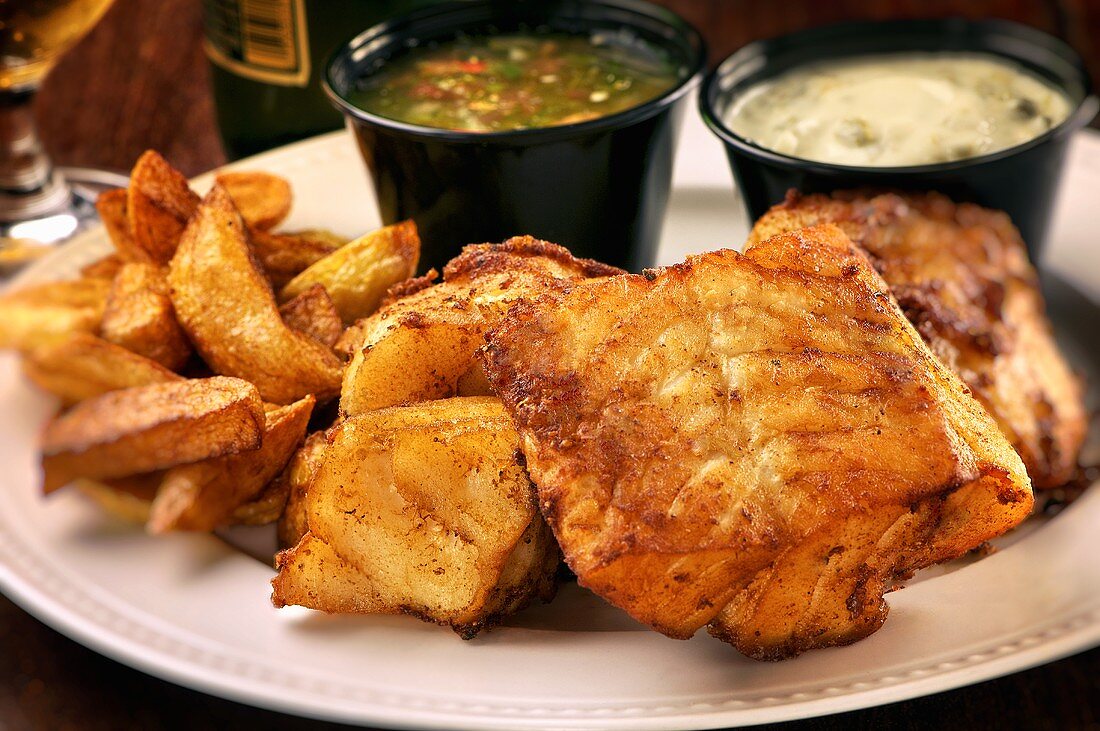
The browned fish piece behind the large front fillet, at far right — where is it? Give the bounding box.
[749,192,1088,488]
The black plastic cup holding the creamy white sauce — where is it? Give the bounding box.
[700,19,1098,259]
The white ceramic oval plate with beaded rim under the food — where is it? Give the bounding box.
[0,109,1100,729]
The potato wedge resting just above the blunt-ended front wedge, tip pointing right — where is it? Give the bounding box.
[23,332,182,405]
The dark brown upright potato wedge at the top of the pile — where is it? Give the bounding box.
[126,149,199,264]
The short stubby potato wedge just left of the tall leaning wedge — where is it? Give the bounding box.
[100,262,191,370]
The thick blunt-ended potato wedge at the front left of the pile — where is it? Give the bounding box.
[42,376,264,492]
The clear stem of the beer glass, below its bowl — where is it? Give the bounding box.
[0,90,69,221]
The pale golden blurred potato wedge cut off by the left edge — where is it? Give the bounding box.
[0,279,111,353]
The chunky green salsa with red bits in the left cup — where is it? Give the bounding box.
[348,33,681,132]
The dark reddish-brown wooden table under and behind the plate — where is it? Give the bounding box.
[0,0,1100,731]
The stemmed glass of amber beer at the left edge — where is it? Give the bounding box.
[0,0,127,270]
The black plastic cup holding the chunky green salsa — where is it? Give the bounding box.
[326,0,706,269]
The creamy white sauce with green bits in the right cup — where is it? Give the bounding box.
[725,54,1071,167]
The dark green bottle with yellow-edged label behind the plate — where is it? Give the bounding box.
[204,0,444,159]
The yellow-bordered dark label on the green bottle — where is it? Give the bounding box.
[204,0,309,87]
